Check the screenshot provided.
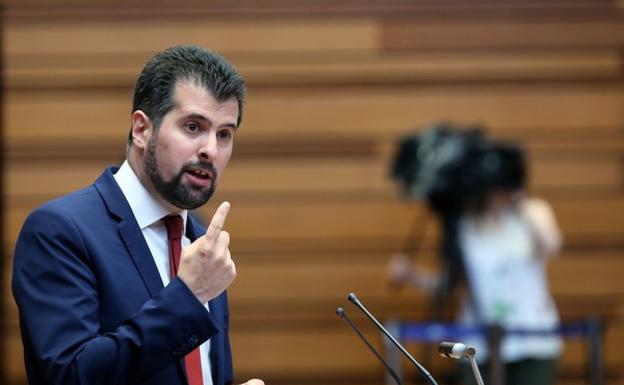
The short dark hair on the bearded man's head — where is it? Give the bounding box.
[128,45,245,145]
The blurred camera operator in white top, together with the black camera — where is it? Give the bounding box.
[388,126,562,385]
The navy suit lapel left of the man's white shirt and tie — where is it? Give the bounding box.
[95,167,163,297]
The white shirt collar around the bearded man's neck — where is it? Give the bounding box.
[113,160,188,230]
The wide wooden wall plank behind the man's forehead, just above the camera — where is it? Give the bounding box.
[5,84,624,142]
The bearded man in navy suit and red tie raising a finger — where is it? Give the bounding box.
[13,46,262,385]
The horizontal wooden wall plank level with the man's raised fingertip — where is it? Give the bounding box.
[5,194,624,250]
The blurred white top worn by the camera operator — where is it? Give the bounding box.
[459,201,562,362]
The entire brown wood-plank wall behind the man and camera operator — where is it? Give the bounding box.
[0,0,624,385]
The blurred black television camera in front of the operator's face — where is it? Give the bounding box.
[391,123,526,216]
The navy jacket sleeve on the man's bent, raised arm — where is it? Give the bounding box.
[12,209,218,385]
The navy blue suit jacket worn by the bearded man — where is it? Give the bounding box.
[13,169,232,385]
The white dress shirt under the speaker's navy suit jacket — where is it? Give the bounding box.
[114,160,212,385]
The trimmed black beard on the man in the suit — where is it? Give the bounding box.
[144,133,217,210]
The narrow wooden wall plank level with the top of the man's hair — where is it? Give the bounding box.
[7,49,622,88]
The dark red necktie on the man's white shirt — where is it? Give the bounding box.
[165,215,204,385]
